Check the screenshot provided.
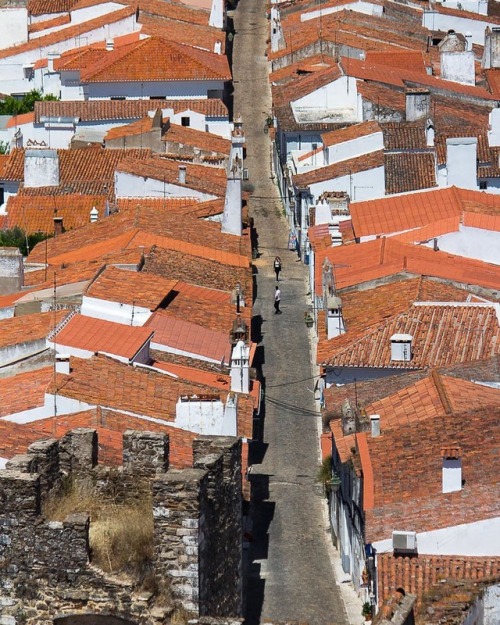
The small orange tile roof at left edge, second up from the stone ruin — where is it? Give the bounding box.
[0,364,54,416]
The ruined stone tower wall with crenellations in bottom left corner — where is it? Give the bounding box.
[0,428,242,625]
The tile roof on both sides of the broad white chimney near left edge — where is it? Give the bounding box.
[4,147,151,187]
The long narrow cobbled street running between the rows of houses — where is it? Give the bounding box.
[234,0,347,625]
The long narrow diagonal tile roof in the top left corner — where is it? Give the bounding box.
[0,6,136,59]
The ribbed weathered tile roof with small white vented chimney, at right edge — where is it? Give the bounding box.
[323,302,500,369]
